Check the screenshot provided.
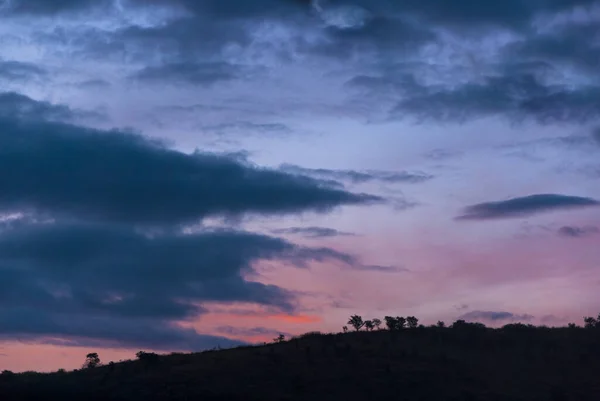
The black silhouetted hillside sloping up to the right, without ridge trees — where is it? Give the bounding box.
[0,324,600,401]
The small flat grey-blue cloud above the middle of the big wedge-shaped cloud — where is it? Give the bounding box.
[133,62,244,85]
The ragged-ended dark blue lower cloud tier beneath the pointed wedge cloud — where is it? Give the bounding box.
[0,223,302,312]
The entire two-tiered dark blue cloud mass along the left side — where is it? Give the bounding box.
[0,93,381,349]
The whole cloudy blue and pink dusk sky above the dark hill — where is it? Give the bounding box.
[0,0,600,371]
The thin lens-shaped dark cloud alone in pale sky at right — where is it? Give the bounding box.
[457,194,600,220]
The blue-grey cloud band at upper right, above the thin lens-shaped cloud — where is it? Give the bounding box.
[372,73,600,124]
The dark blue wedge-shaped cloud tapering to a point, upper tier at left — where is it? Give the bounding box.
[0,94,381,224]
